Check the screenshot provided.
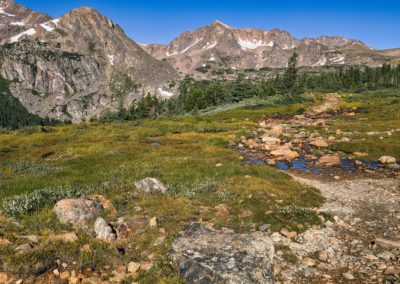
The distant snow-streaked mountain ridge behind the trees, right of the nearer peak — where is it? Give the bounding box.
[142,21,396,73]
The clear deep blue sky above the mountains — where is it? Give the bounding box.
[17,0,400,49]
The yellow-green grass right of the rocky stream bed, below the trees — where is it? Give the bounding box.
[328,89,400,160]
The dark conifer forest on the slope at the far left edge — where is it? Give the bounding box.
[0,76,60,129]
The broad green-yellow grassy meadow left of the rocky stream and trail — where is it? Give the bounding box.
[0,100,323,283]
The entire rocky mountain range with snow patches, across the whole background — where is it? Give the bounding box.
[0,0,400,122]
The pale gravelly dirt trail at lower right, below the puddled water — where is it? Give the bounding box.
[282,176,400,283]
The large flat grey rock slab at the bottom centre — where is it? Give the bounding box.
[171,224,274,284]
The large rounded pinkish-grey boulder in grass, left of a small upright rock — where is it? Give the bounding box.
[53,199,103,226]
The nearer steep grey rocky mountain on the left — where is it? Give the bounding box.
[0,3,178,121]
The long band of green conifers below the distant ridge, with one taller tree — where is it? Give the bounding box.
[100,53,400,122]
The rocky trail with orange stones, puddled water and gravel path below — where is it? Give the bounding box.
[239,94,400,283]
